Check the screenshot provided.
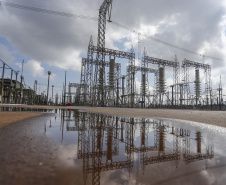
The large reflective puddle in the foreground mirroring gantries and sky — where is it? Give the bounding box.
[43,110,226,184]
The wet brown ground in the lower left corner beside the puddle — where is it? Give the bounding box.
[0,112,91,185]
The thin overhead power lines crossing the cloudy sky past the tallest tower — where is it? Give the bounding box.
[0,1,224,61]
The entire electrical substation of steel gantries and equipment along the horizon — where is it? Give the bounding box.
[0,0,224,109]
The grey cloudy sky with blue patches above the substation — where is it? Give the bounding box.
[0,0,226,98]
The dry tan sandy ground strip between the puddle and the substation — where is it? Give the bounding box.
[0,105,226,127]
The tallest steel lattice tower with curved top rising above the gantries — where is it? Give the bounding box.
[94,0,113,106]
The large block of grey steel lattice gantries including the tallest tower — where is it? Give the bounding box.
[72,0,219,108]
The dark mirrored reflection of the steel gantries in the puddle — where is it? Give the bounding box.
[54,110,214,184]
